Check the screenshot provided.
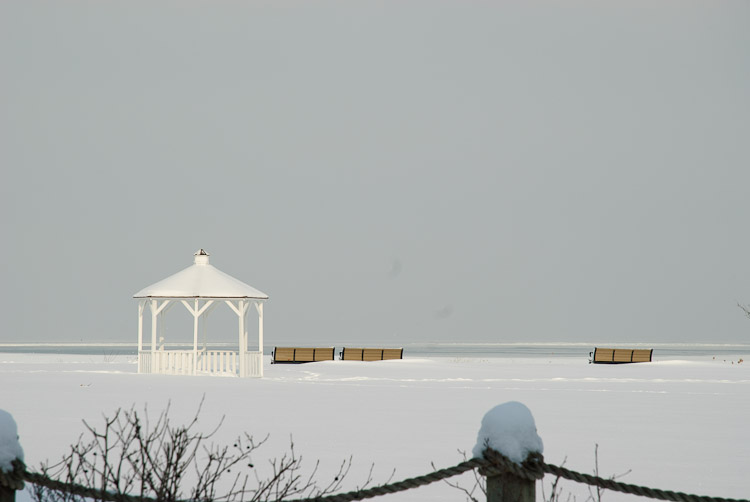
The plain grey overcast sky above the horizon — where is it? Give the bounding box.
[0,0,750,345]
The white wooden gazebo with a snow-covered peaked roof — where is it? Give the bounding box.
[133,249,268,377]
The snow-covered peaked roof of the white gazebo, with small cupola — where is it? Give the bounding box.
[133,249,268,300]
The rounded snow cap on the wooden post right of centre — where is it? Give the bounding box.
[472,401,544,464]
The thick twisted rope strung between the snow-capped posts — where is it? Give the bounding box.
[0,449,750,502]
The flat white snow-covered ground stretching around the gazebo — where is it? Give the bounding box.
[0,354,750,502]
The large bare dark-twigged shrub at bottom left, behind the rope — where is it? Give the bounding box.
[33,402,354,502]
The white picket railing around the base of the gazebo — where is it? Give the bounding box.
[138,350,263,377]
